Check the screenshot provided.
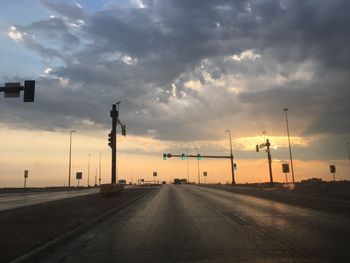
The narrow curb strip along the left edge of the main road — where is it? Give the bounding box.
[9,188,157,263]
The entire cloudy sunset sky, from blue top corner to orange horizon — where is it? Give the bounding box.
[0,0,350,187]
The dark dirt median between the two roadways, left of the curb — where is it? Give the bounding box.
[0,187,157,262]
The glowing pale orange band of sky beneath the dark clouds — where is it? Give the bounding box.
[0,129,350,187]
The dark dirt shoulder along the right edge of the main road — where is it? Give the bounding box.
[203,181,350,217]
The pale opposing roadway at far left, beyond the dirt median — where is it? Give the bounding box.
[0,188,100,211]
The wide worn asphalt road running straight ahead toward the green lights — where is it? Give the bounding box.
[42,185,350,262]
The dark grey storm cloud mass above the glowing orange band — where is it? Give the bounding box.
[2,0,350,159]
